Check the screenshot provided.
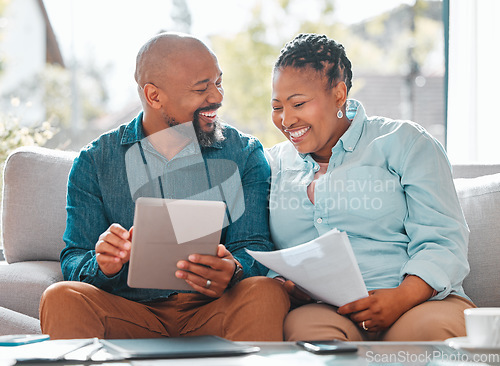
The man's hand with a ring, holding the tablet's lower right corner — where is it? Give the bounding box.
[175,244,236,297]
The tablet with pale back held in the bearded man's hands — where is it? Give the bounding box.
[127,197,226,290]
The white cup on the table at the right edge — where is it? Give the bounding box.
[464,308,500,348]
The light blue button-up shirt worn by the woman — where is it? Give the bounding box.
[267,100,469,299]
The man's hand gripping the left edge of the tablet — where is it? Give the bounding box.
[95,224,134,277]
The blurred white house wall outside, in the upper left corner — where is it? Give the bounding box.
[0,0,46,124]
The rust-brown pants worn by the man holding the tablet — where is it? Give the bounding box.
[40,277,290,341]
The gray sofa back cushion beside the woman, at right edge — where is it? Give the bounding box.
[455,173,500,306]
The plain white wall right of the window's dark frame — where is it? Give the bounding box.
[447,0,500,163]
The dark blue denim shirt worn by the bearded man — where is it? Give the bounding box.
[61,113,273,302]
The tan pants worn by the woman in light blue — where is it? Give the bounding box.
[284,295,475,341]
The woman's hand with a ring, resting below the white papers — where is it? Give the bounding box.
[337,276,434,332]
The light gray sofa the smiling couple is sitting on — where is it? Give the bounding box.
[0,148,500,335]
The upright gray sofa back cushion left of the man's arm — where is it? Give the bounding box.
[2,147,76,263]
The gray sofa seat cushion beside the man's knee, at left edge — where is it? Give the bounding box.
[0,261,63,318]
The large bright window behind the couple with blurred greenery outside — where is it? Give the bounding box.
[0,0,446,149]
